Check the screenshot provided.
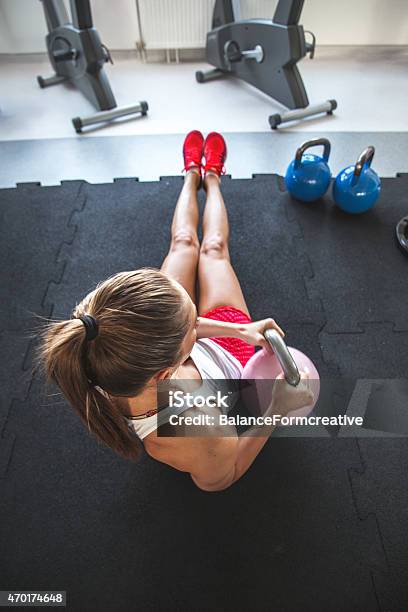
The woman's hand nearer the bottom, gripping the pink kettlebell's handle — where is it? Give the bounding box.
[269,368,314,416]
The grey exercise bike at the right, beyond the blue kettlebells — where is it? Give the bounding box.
[196,0,337,129]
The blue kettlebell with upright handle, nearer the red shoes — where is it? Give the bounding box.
[285,138,331,202]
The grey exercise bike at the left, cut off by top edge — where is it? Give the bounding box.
[37,0,149,133]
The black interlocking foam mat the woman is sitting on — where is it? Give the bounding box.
[0,175,408,612]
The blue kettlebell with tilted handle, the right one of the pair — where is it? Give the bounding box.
[333,147,381,214]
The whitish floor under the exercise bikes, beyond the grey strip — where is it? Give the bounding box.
[0,47,408,140]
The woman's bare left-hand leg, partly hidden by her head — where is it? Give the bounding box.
[161,171,200,302]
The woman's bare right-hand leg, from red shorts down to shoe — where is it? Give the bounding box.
[198,173,249,315]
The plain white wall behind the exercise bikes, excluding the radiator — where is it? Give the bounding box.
[0,0,408,53]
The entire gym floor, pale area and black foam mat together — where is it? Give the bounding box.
[0,47,408,612]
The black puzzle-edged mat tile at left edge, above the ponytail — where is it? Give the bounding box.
[0,181,85,331]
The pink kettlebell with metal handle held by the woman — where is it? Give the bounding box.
[241,329,320,417]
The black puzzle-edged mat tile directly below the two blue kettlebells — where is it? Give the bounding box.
[283,175,408,332]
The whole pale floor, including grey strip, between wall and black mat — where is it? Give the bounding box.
[0,46,408,187]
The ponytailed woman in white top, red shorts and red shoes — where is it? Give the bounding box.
[38,131,312,491]
